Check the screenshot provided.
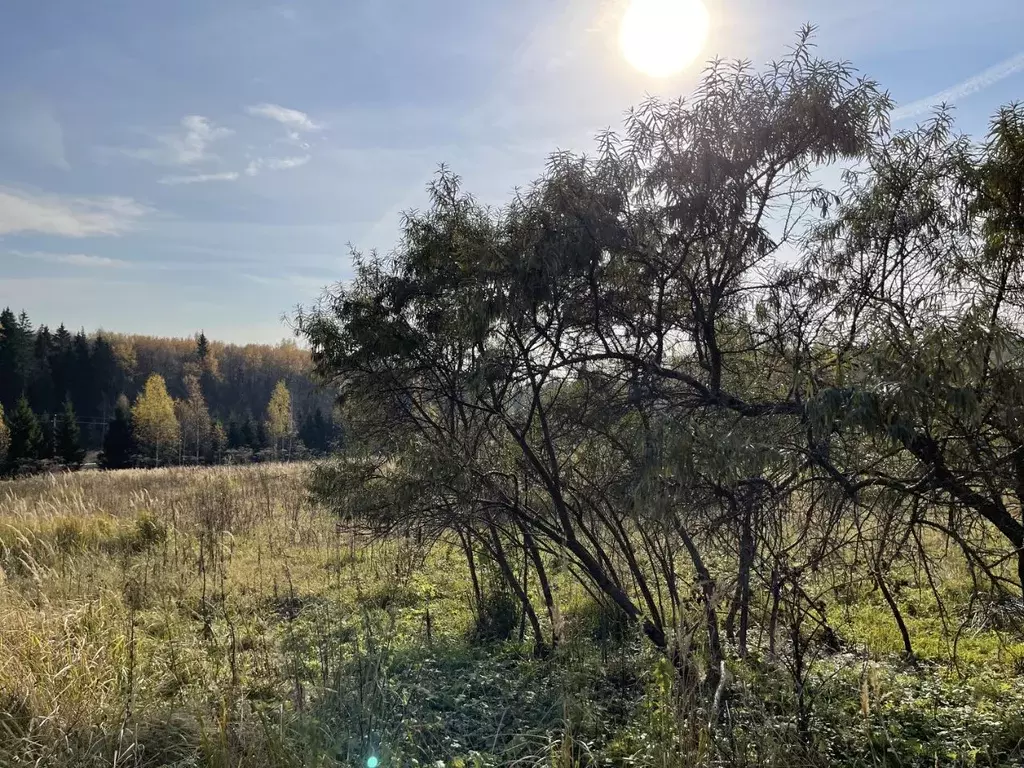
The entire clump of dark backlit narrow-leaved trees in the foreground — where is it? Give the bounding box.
[297,32,1024,730]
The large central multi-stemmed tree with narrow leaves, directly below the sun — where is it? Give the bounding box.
[298,33,888,679]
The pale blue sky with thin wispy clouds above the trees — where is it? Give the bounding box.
[0,0,1024,343]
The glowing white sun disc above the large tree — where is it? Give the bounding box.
[618,0,711,78]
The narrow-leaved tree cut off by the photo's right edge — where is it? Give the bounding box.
[794,106,1024,591]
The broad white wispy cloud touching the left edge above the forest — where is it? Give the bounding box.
[0,187,151,238]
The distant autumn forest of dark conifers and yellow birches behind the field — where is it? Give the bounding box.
[0,308,341,474]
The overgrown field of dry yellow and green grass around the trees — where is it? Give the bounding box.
[0,465,1024,768]
